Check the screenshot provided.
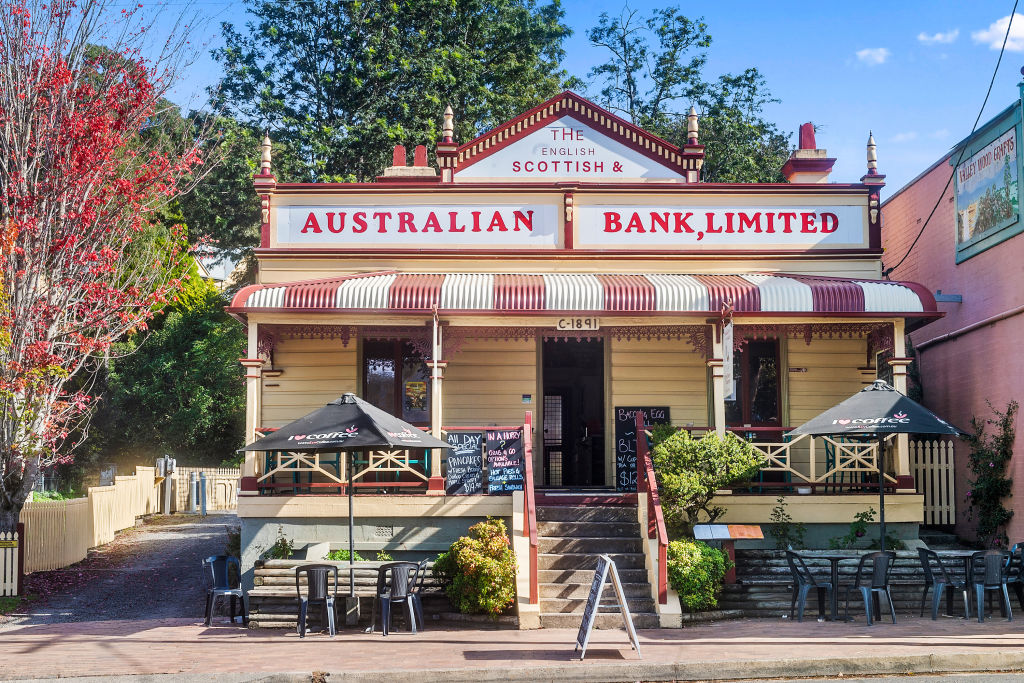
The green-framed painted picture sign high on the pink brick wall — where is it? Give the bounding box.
[954,126,1020,246]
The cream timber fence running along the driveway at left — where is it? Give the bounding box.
[14,467,239,583]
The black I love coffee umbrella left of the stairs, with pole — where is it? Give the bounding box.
[242,393,450,596]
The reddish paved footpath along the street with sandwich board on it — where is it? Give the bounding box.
[0,617,1024,683]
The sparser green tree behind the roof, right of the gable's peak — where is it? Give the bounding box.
[587,7,790,182]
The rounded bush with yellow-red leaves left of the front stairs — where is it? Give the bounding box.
[434,517,516,616]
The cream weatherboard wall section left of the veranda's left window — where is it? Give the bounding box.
[259,338,358,427]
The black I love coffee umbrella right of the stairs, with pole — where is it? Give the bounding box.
[787,380,965,550]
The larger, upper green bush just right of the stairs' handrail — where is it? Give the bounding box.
[653,431,764,538]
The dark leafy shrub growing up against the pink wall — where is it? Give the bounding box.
[965,400,1017,548]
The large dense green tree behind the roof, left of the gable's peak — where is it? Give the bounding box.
[215,0,569,181]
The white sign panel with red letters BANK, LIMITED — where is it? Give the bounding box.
[575,205,867,251]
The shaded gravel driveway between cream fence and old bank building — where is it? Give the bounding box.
[0,513,238,629]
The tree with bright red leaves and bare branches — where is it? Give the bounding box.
[0,0,202,531]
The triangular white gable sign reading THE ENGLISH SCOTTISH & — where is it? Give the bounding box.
[456,117,683,180]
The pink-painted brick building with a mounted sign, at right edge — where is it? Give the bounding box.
[882,83,1024,542]
